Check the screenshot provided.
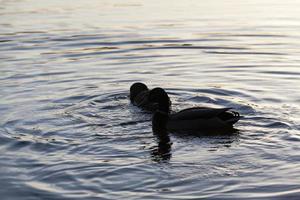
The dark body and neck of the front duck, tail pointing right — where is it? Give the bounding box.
[149,91,241,133]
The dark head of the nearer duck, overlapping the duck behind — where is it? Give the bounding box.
[149,87,171,113]
